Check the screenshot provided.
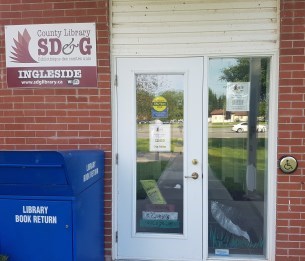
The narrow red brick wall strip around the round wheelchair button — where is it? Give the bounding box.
[276,0,305,261]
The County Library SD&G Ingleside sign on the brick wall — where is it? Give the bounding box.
[5,23,97,87]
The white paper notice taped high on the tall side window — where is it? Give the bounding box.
[226,82,250,111]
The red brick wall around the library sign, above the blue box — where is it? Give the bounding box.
[0,0,112,256]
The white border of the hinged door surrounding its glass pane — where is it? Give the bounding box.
[114,57,207,261]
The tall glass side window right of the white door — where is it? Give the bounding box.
[208,57,270,255]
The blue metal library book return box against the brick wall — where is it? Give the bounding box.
[0,150,104,261]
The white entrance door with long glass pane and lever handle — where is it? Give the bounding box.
[116,58,208,261]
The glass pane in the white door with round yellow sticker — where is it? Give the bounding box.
[136,74,184,234]
